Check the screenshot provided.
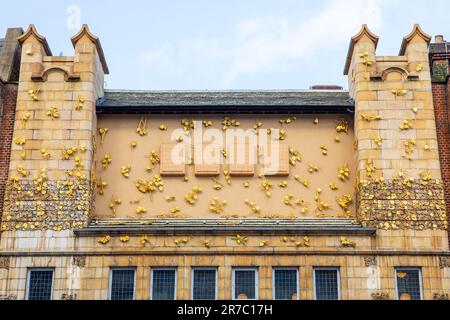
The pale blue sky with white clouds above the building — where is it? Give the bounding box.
[0,0,450,90]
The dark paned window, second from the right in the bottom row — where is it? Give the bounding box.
[314,268,340,300]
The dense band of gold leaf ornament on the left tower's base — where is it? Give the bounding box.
[1,179,92,231]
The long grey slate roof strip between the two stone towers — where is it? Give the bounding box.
[97,90,354,113]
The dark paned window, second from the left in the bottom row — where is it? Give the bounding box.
[109,268,135,300]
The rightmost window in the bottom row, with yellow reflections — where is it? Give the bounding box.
[395,268,422,300]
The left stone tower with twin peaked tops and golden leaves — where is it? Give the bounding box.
[2,25,109,231]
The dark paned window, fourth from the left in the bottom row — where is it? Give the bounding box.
[192,268,217,300]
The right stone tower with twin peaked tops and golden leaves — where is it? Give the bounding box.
[344,25,447,230]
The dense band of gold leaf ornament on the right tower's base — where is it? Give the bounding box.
[356,178,448,230]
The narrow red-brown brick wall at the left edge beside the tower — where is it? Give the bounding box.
[0,81,17,228]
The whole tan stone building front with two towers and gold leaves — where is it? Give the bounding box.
[0,25,450,300]
